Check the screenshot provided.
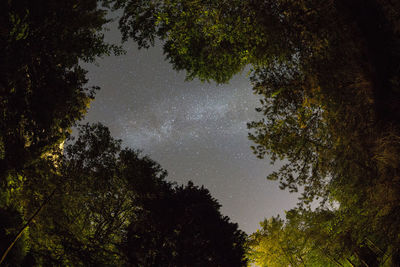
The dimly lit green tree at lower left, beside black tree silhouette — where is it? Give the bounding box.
[24,125,162,266]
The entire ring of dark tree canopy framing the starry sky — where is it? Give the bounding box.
[0,0,400,266]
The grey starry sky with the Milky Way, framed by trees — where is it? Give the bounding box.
[83,21,296,233]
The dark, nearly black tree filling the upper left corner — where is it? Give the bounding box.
[0,0,120,182]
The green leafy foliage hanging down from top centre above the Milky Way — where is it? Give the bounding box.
[114,0,279,83]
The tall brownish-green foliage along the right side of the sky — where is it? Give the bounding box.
[249,1,400,266]
